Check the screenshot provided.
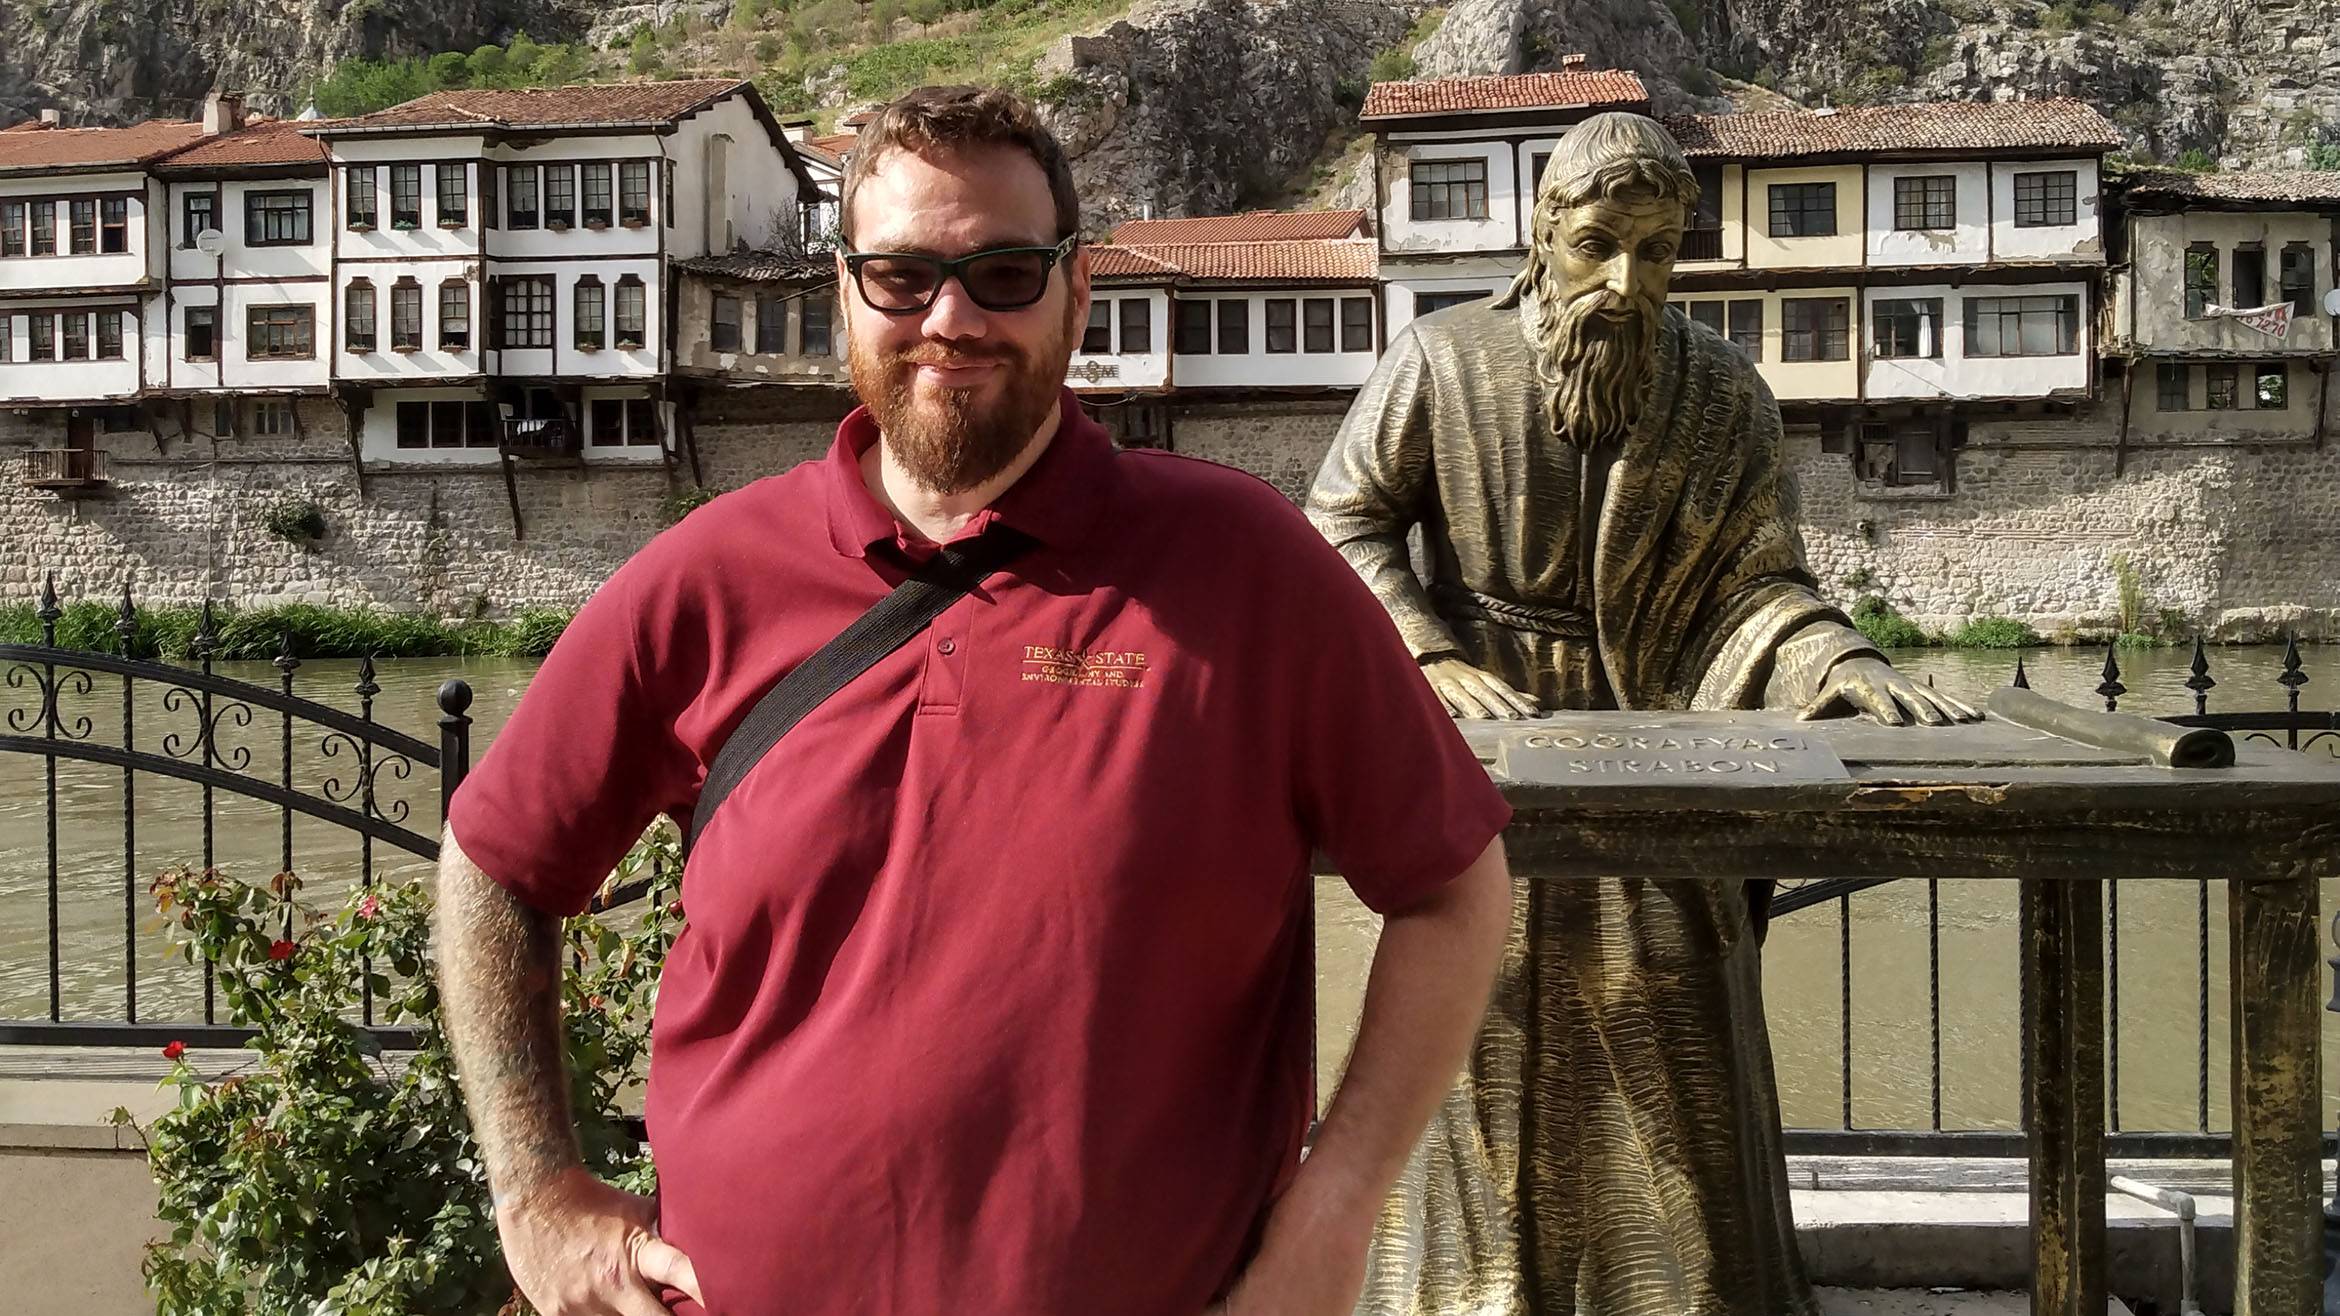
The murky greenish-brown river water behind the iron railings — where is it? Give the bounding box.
[0,649,2340,1129]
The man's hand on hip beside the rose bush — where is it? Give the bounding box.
[496,1168,707,1316]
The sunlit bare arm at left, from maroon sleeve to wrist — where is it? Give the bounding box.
[438,831,583,1201]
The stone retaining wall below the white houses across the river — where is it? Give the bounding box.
[13,391,2340,639]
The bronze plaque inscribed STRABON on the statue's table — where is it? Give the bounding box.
[1495,719,1851,787]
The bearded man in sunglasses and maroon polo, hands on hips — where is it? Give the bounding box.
[438,87,1509,1316]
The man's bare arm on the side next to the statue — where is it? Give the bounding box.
[1226,838,1512,1316]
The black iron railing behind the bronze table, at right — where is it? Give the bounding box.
[1769,637,2340,1157]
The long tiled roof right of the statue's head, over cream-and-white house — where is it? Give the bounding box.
[1666,98,2127,159]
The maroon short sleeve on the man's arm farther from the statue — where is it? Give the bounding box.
[447,550,700,916]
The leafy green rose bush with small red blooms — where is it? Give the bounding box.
[115,827,681,1316]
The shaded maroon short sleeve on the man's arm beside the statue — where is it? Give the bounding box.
[1287,517,1512,913]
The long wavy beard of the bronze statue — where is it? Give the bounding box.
[1535,276,1664,447]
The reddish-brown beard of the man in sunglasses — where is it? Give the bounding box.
[845,297,1072,494]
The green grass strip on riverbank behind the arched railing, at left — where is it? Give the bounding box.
[0,599,573,663]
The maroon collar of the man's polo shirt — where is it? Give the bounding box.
[824,389,1114,557]
